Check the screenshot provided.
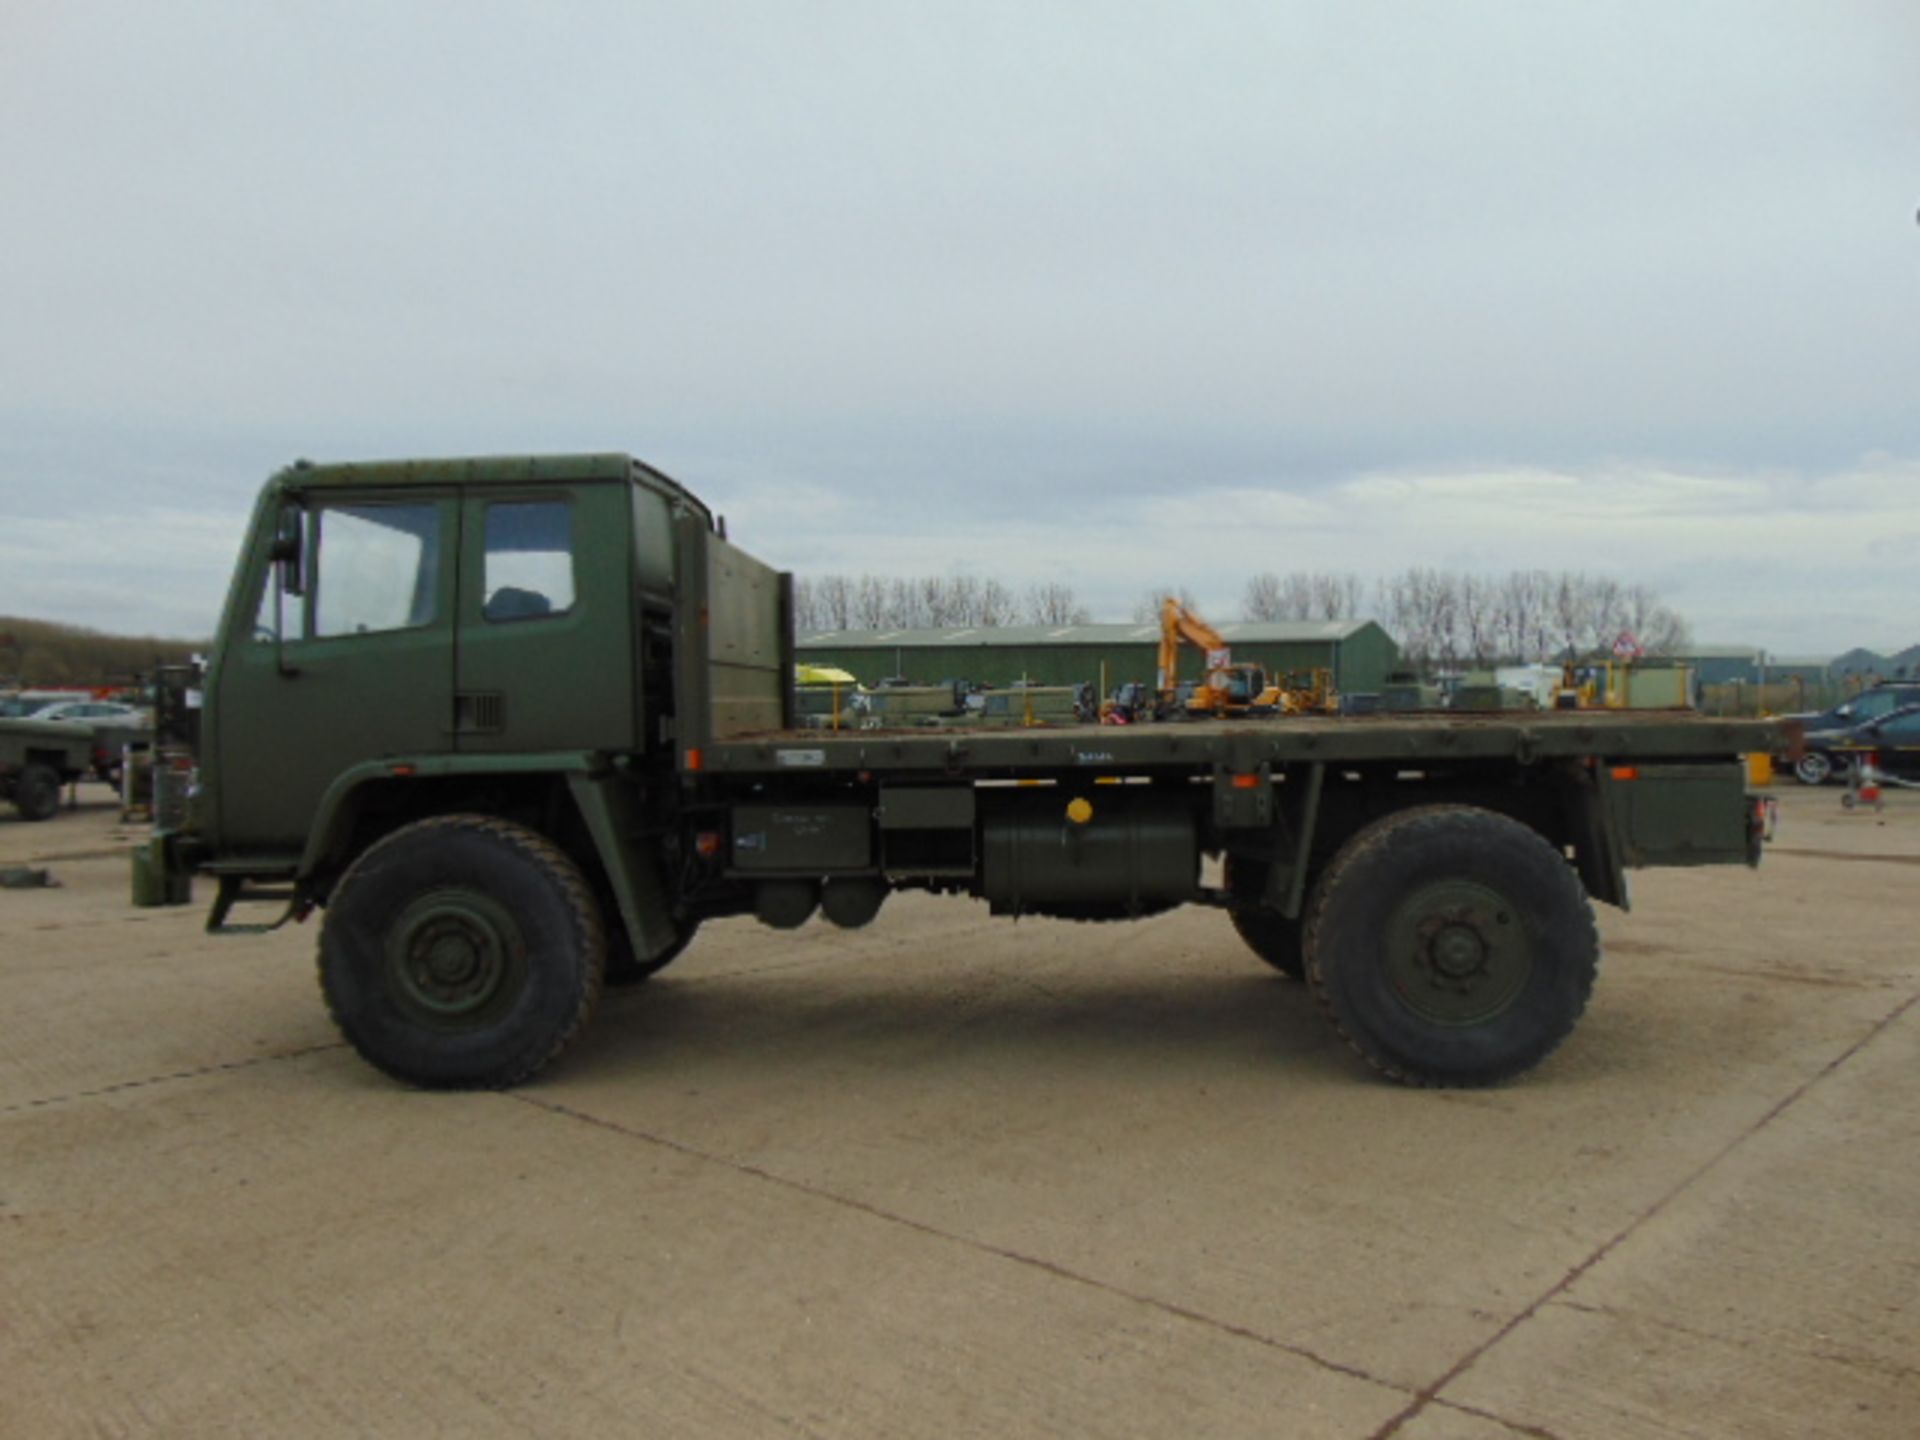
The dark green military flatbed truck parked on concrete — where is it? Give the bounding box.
[138,455,1774,1087]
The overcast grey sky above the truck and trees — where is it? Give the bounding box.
[0,0,1920,653]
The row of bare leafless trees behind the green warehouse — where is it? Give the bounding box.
[793,566,1692,666]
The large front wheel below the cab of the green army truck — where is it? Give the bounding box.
[319,814,607,1089]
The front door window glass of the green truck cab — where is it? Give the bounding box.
[314,503,440,637]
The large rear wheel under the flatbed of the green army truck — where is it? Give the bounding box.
[1306,804,1599,1085]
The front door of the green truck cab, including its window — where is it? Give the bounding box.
[213,490,459,856]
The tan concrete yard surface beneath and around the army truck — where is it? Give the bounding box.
[0,785,1920,1440]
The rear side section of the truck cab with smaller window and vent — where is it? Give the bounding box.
[453,482,636,755]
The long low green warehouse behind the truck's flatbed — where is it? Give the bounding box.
[795,620,1400,695]
